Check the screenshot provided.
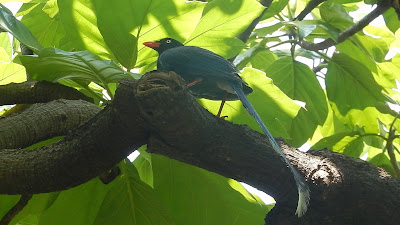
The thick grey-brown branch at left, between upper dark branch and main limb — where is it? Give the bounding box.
[0,100,100,149]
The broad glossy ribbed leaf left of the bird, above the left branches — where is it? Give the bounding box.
[20,48,132,88]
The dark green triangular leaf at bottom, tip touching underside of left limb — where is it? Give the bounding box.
[93,160,175,225]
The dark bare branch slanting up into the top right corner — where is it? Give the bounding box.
[298,0,391,51]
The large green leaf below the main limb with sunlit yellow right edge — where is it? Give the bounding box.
[152,154,268,225]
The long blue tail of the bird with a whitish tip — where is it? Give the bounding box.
[230,82,310,217]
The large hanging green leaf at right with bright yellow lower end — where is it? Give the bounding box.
[325,54,386,132]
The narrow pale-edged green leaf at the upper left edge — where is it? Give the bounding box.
[0,5,43,52]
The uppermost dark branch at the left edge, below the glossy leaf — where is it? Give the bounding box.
[0,81,93,105]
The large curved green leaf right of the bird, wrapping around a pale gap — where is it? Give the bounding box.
[266,57,328,146]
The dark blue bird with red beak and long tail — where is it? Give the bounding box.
[143,38,310,217]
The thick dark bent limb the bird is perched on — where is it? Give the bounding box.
[0,73,400,225]
